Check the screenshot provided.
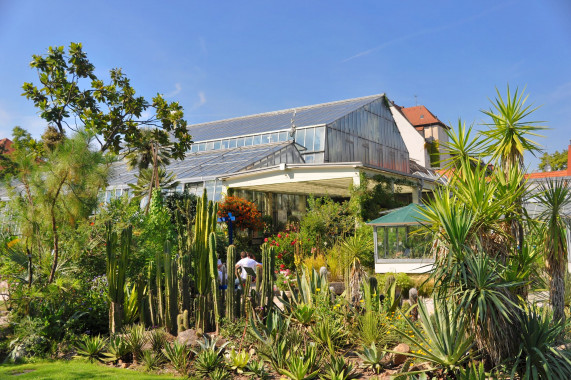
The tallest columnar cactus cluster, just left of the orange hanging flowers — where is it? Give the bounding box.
[193,189,218,331]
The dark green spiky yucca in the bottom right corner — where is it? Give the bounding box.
[511,306,571,380]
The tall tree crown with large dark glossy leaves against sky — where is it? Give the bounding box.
[23,42,192,159]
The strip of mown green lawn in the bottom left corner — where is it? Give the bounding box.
[0,360,181,380]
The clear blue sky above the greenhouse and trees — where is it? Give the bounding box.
[0,0,571,167]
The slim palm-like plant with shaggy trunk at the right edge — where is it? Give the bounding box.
[535,180,571,319]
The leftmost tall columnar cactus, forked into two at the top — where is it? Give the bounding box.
[106,224,133,333]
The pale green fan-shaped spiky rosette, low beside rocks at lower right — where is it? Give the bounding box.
[397,298,474,375]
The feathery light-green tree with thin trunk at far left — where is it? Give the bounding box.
[8,131,110,283]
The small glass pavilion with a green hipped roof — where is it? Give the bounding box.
[367,203,434,273]
